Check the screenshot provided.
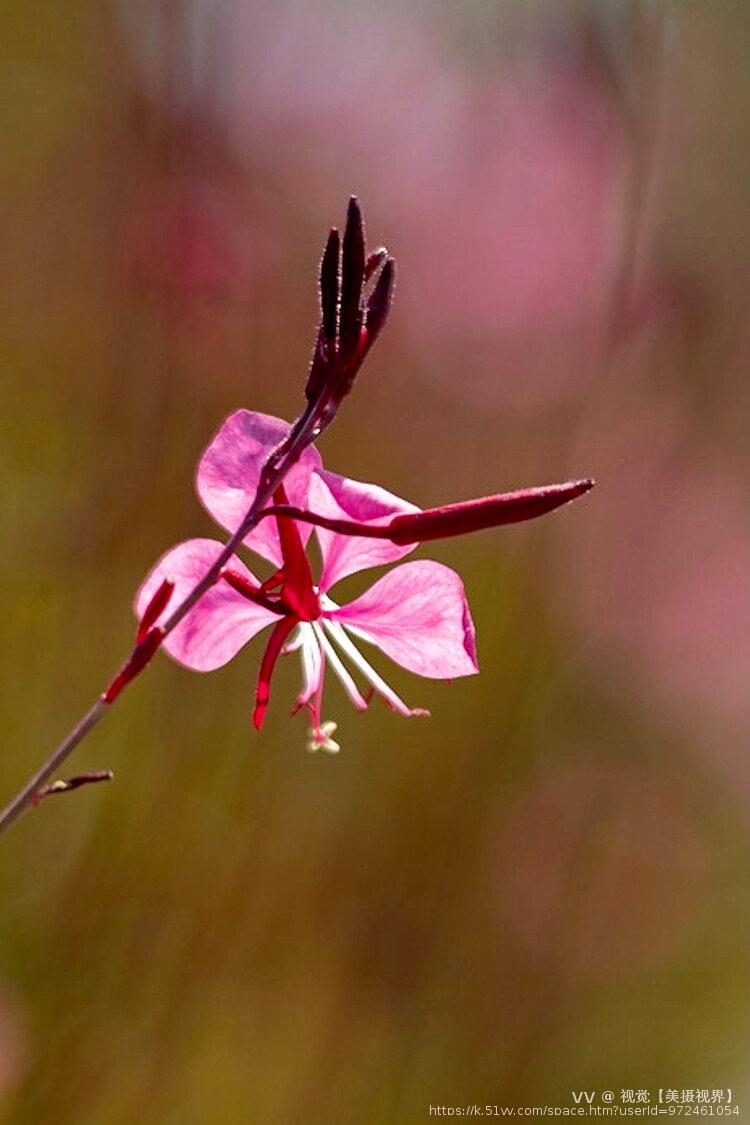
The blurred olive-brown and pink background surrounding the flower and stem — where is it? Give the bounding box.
[0,0,750,1125]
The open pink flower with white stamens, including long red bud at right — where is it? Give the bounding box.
[135,411,590,752]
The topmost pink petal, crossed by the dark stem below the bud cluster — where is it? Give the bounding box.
[196,411,322,566]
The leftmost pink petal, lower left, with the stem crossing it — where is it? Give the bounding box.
[134,539,278,672]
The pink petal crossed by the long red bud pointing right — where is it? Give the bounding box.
[308,469,419,591]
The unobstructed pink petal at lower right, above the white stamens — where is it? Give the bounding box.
[325,559,479,680]
